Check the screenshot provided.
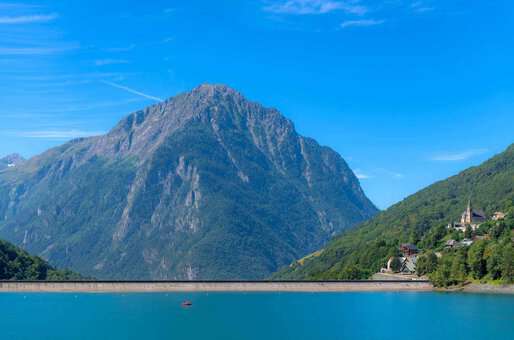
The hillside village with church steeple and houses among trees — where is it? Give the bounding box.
[373,200,514,280]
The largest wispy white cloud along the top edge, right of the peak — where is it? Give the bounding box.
[264,0,368,15]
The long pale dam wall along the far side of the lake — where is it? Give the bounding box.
[0,281,434,293]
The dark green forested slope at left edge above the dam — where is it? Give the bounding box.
[0,240,81,281]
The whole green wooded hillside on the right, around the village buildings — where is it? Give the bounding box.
[273,145,514,286]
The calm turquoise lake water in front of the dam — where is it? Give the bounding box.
[0,293,514,340]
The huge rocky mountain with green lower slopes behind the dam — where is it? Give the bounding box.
[0,85,377,279]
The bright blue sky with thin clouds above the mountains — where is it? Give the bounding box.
[0,0,514,208]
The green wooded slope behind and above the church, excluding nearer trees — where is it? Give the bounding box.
[274,145,514,279]
